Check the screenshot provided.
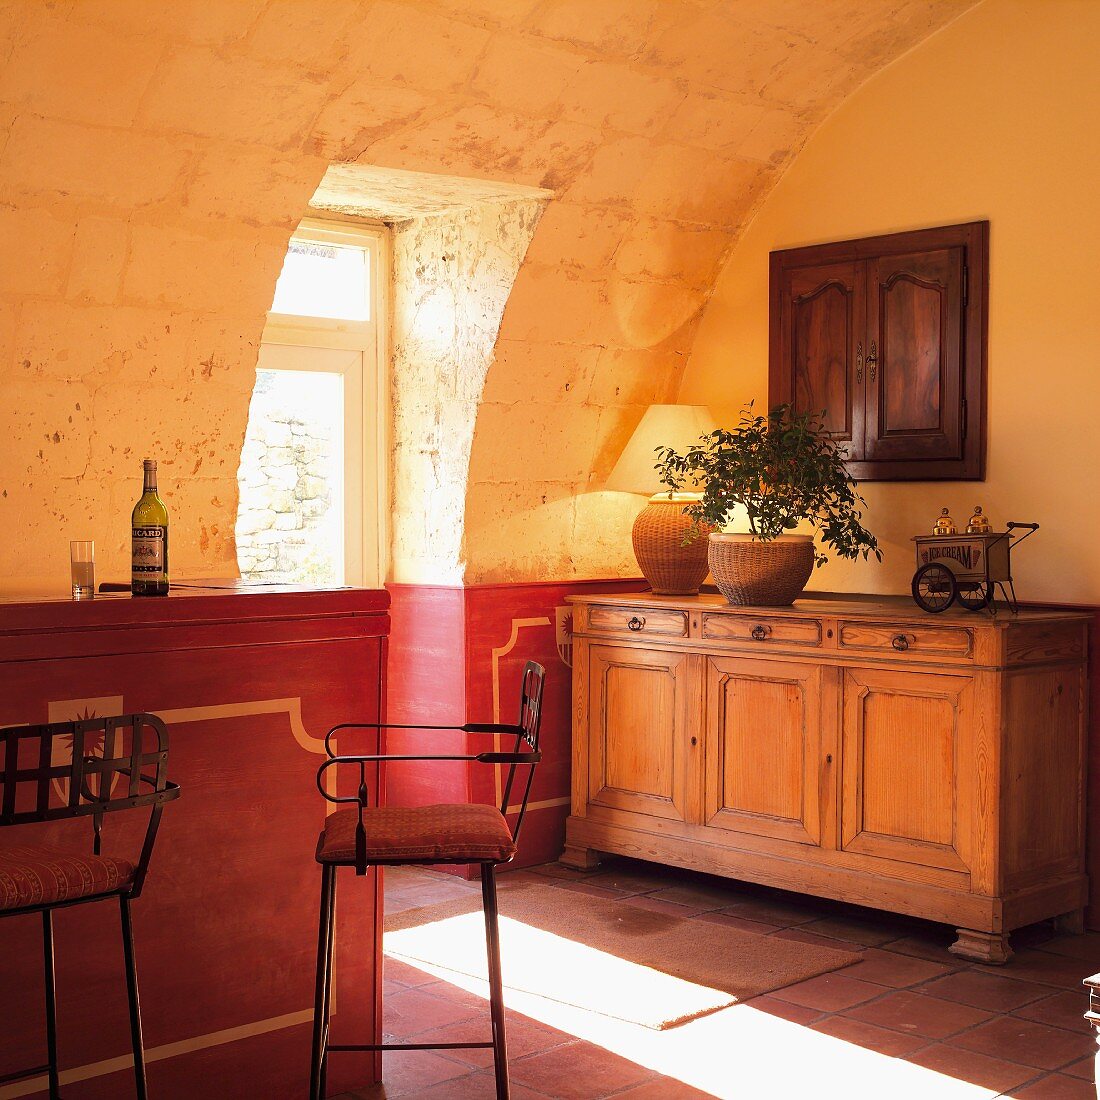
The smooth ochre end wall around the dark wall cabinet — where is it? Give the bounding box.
[681,0,1100,603]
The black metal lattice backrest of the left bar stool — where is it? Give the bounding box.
[0,714,179,897]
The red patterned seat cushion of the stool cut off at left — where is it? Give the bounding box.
[0,844,136,910]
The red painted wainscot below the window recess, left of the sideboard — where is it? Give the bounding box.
[386,578,647,873]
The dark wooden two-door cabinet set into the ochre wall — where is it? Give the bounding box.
[769,221,989,481]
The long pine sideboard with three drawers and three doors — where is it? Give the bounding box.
[562,593,1088,963]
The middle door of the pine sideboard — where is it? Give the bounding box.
[705,658,822,845]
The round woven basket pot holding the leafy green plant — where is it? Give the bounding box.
[707,535,814,607]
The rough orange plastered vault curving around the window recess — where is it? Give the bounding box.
[0,0,970,592]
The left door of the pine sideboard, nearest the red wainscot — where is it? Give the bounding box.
[589,646,697,821]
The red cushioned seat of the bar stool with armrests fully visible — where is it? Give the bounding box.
[317,805,516,864]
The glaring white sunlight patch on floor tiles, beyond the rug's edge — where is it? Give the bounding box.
[387,942,998,1100]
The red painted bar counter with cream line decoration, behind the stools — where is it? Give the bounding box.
[0,582,389,1100]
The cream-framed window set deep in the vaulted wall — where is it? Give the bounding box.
[237,222,385,587]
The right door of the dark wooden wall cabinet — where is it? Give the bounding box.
[865,248,964,461]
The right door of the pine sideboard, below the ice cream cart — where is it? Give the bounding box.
[840,669,972,871]
